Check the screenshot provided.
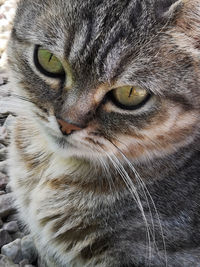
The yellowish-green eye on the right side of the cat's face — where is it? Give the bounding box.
[112,86,149,109]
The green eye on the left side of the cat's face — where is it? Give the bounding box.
[36,48,65,77]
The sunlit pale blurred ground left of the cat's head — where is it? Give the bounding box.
[0,0,18,70]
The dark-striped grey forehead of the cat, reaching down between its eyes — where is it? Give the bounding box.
[15,0,175,82]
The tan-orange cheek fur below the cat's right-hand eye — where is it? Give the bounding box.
[115,110,198,162]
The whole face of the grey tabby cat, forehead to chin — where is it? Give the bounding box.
[9,0,200,162]
